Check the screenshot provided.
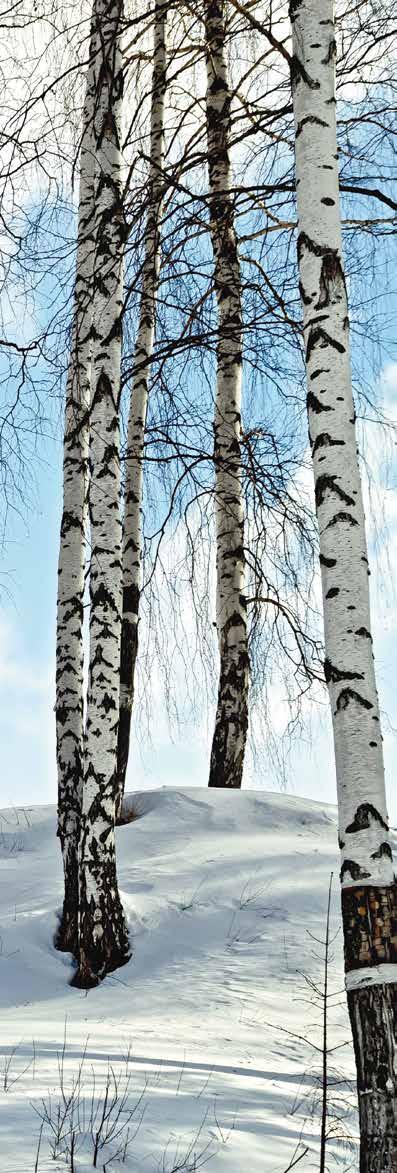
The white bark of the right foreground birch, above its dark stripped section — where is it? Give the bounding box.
[291,0,393,887]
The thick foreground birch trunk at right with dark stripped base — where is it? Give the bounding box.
[290,0,397,1173]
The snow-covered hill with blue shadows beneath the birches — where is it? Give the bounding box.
[0,788,366,1173]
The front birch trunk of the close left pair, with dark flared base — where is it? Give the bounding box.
[75,0,129,986]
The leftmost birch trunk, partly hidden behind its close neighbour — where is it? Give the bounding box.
[55,20,96,952]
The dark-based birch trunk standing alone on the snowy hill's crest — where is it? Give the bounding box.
[204,0,249,787]
